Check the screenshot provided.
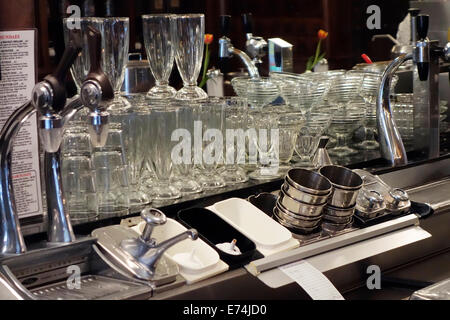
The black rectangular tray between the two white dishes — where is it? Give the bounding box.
[177,208,264,269]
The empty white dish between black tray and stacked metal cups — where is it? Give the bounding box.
[210,198,292,250]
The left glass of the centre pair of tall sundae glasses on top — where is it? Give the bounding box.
[142,14,177,99]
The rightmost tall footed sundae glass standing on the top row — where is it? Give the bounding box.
[171,14,208,100]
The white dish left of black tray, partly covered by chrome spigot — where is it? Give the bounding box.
[133,218,228,283]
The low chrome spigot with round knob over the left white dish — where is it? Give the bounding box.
[120,208,198,273]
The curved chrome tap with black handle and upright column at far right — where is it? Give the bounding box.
[377,15,450,166]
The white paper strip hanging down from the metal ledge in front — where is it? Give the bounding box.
[279,260,344,300]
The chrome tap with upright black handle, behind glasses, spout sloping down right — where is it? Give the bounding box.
[219,15,259,78]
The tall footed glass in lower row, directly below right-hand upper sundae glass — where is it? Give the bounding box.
[170,101,203,194]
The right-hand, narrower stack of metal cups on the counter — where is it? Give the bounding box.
[319,165,363,233]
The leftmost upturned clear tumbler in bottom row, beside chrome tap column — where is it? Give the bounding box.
[61,154,98,221]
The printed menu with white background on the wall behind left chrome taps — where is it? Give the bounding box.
[0,30,42,218]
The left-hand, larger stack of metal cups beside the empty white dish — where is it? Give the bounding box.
[274,168,332,235]
